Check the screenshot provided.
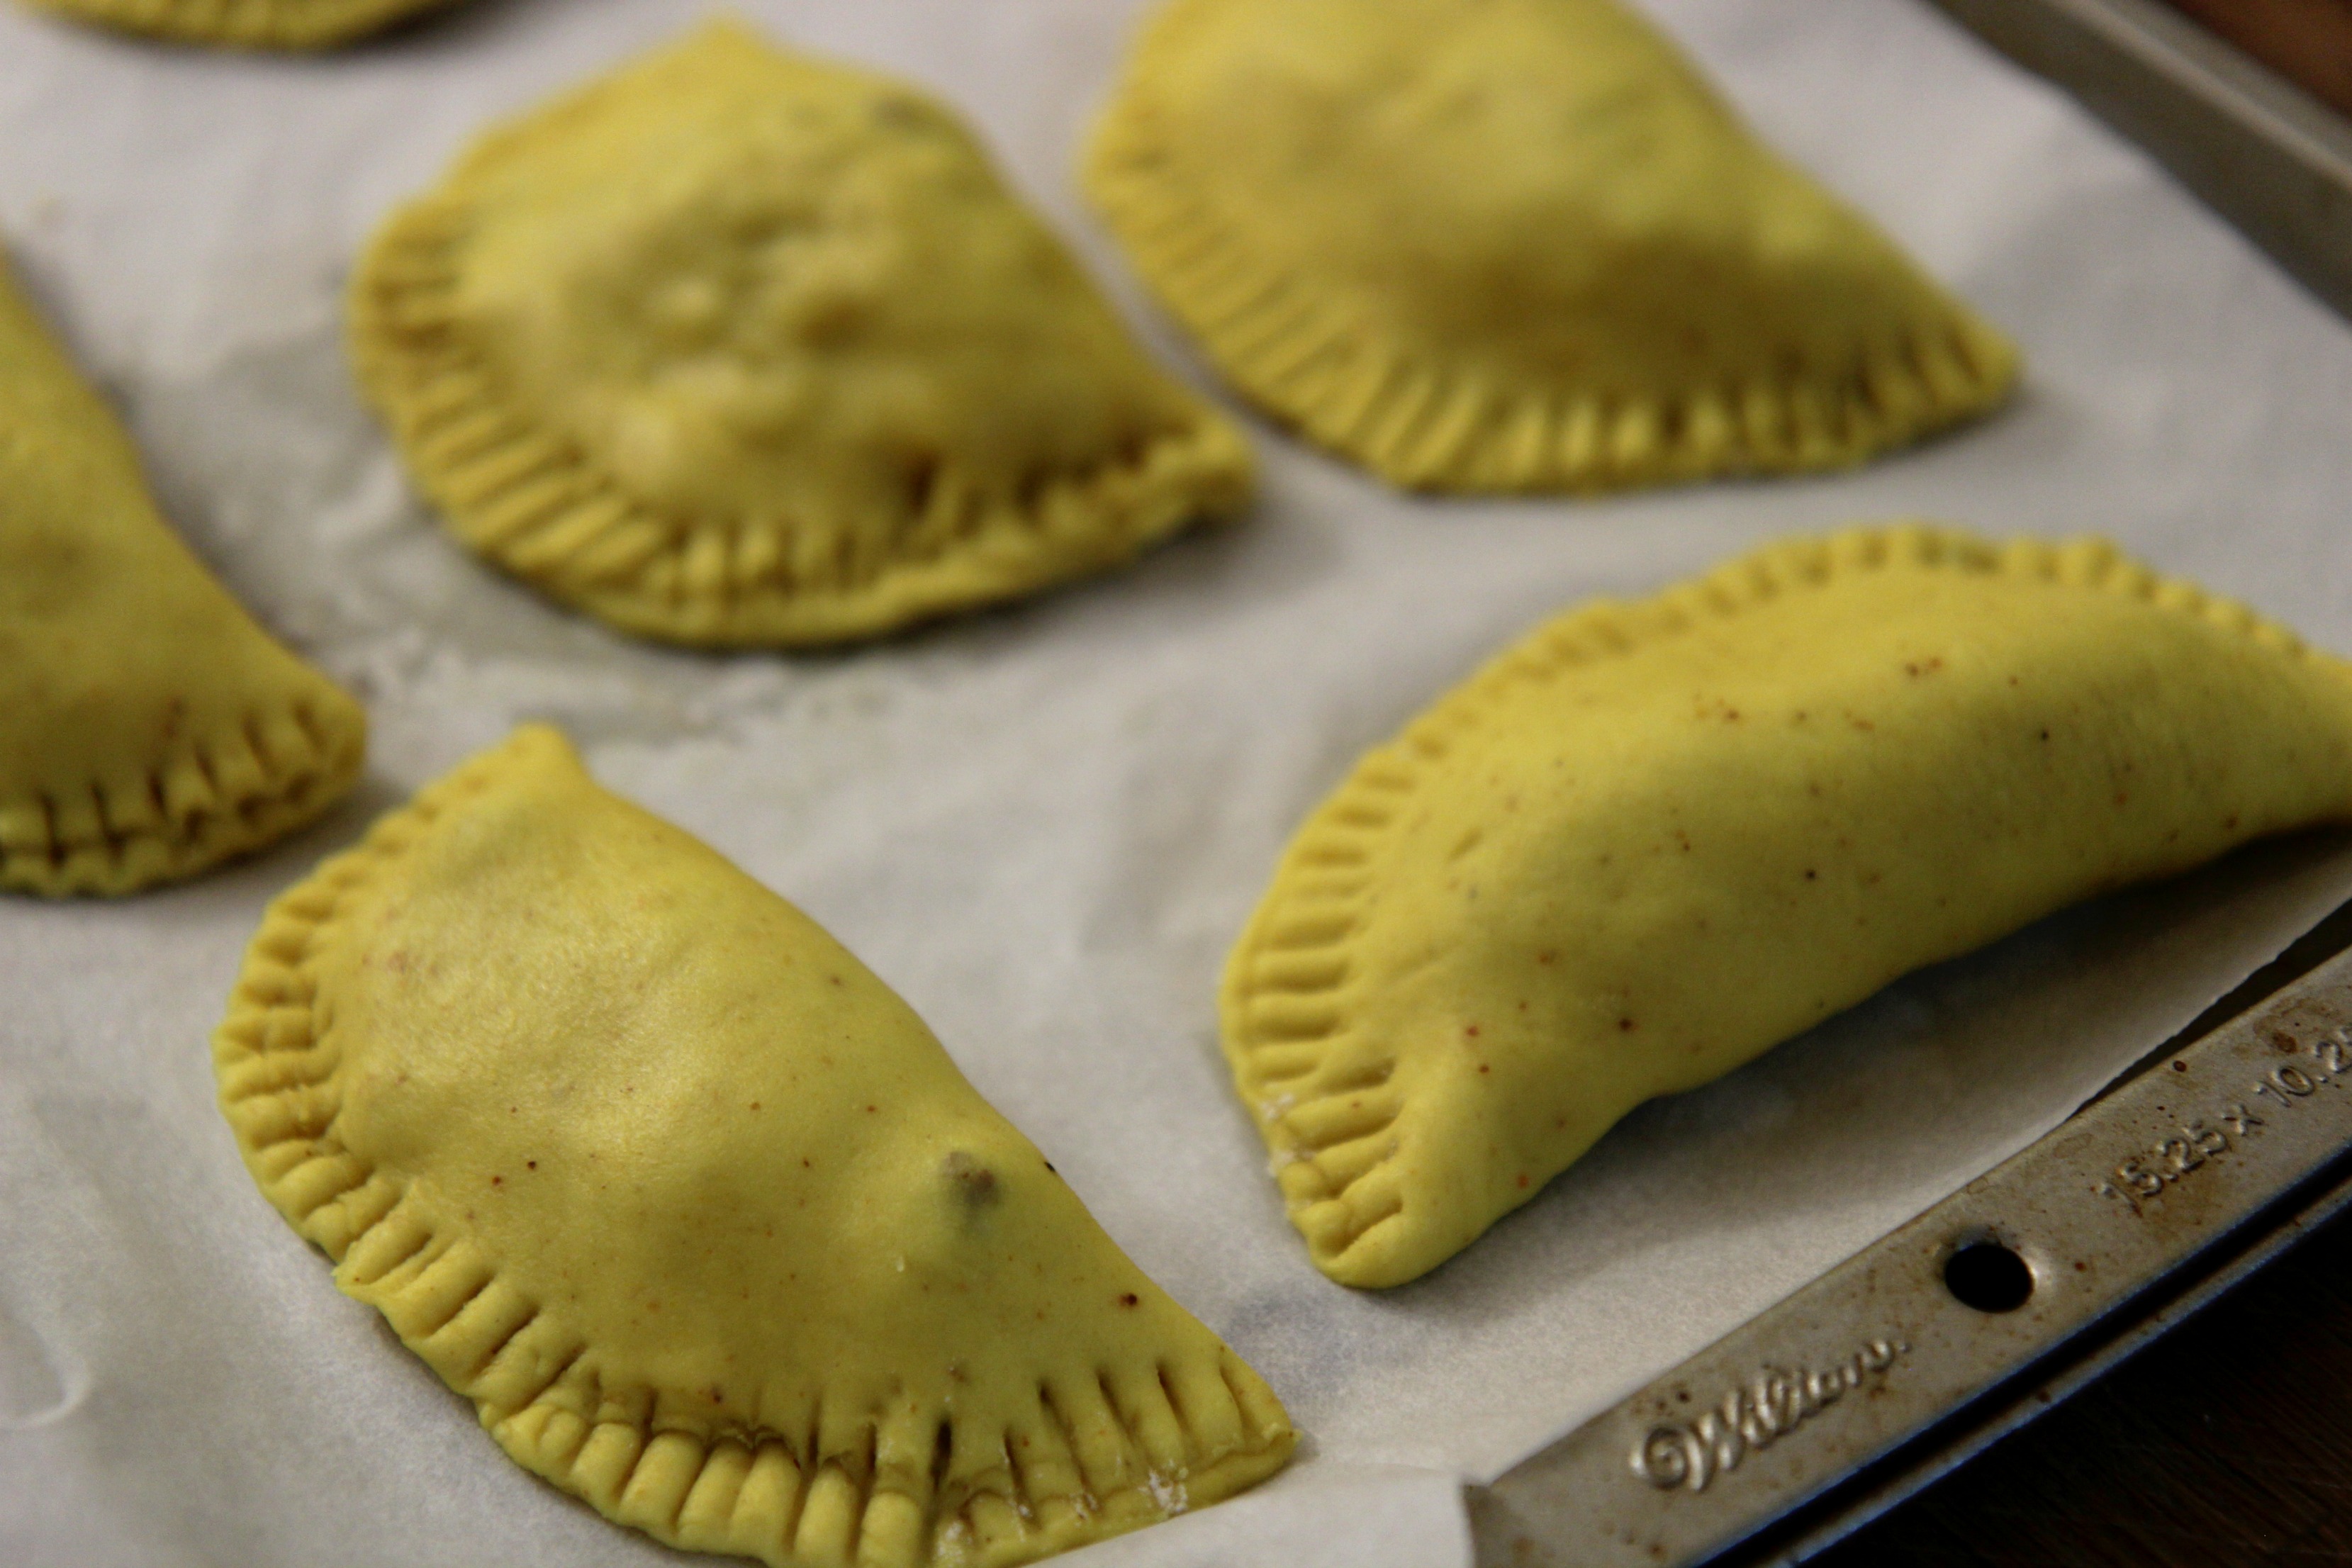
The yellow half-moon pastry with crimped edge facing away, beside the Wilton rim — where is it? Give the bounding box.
[1223,527,2352,1286]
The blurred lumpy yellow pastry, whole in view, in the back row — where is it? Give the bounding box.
[350,21,1253,644]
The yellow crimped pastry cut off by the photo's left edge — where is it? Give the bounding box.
[0,256,367,896]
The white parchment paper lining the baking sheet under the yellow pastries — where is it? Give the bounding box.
[0,0,2352,1568]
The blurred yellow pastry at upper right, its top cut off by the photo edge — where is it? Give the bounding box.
[1085,0,2016,491]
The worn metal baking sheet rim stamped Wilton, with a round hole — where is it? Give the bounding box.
[1470,902,2352,1568]
